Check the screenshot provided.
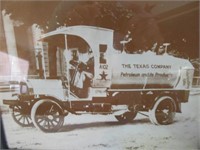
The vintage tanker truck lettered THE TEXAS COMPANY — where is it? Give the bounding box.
[3,26,194,132]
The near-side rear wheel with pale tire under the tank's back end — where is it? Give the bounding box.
[149,96,176,125]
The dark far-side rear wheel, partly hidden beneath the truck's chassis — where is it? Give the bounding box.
[115,111,137,123]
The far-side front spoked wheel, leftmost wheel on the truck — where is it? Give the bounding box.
[12,105,33,127]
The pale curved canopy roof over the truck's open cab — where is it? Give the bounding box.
[41,25,113,53]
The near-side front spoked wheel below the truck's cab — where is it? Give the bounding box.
[31,99,64,132]
